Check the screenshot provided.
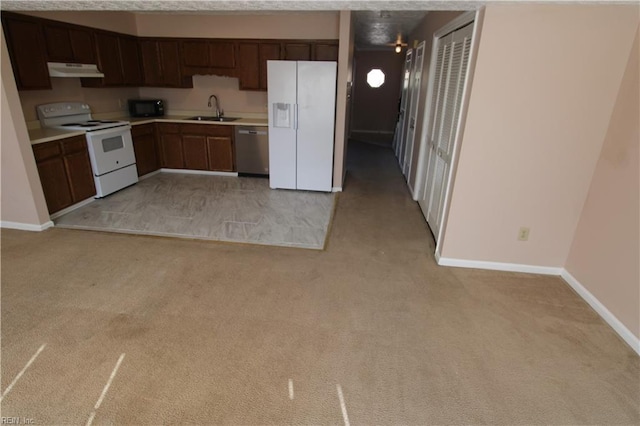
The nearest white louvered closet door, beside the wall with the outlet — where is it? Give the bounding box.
[419,23,473,239]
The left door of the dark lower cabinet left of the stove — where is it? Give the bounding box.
[37,157,73,214]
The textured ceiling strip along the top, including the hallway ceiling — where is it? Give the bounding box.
[0,0,481,49]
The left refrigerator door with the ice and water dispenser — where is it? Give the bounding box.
[267,61,297,189]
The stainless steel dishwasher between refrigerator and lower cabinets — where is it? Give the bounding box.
[236,126,269,175]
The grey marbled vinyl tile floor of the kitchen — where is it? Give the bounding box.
[54,173,335,250]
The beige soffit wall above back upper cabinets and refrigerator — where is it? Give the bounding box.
[136,12,340,39]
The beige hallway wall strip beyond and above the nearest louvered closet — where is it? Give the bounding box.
[405,11,465,188]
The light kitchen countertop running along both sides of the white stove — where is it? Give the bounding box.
[29,114,268,145]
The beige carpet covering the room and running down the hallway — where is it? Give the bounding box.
[1,143,640,425]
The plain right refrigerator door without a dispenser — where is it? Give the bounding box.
[295,61,337,192]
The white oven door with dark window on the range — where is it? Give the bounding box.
[87,125,136,176]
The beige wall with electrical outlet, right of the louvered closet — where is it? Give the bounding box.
[440,4,639,267]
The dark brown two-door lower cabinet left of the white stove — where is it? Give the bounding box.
[33,136,96,214]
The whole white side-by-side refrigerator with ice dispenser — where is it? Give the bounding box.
[267,61,337,191]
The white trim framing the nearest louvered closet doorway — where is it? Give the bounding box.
[413,7,484,259]
